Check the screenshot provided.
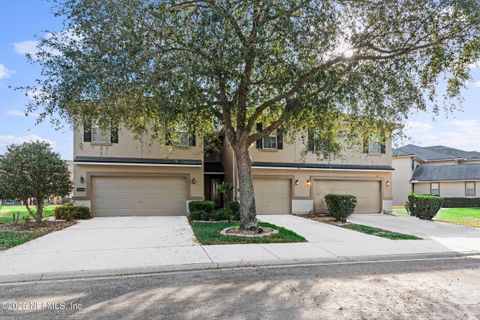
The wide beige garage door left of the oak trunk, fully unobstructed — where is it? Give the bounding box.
[92,177,187,217]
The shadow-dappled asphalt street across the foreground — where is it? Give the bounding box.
[0,256,480,320]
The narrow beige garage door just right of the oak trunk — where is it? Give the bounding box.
[253,179,291,214]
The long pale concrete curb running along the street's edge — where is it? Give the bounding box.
[0,252,480,285]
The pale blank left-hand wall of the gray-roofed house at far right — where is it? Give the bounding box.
[392,156,413,206]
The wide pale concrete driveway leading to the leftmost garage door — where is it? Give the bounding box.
[0,216,211,276]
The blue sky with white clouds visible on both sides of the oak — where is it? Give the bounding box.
[0,0,480,159]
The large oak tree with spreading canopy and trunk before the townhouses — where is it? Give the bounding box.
[30,0,480,228]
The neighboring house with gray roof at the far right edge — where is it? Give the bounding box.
[392,144,480,205]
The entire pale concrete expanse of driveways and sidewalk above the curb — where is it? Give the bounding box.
[0,215,480,282]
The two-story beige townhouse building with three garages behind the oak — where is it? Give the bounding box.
[74,127,393,216]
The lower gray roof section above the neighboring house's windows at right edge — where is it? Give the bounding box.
[412,163,480,181]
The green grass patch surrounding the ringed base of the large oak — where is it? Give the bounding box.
[190,221,306,245]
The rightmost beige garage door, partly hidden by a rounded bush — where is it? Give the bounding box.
[313,180,381,213]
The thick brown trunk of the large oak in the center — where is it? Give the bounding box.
[235,143,257,231]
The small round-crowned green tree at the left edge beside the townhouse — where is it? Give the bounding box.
[0,141,72,223]
